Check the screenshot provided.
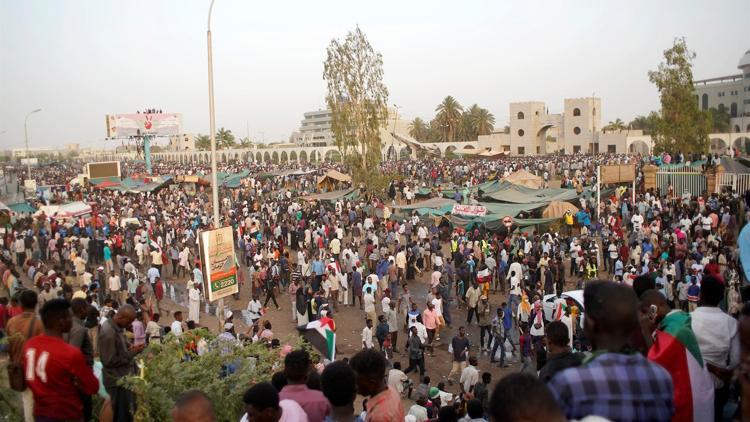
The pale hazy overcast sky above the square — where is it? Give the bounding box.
[0,0,750,149]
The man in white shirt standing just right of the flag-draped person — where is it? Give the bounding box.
[690,276,740,415]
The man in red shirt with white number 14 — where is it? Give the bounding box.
[23,299,99,421]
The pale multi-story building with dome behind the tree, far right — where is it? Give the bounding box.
[694,50,750,133]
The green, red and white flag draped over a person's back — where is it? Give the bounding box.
[648,311,714,421]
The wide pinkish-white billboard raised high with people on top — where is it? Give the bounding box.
[106,113,182,138]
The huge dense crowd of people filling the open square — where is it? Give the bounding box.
[0,154,750,422]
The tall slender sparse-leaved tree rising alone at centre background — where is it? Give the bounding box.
[323,27,388,178]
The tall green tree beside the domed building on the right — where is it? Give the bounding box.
[648,38,711,154]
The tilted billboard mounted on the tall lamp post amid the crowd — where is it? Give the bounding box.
[198,227,239,302]
